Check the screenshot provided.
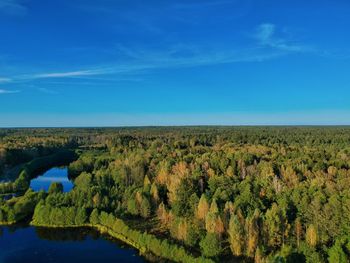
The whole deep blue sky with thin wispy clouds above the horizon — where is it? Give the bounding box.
[0,0,350,127]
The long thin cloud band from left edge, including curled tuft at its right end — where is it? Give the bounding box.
[0,23,314,84]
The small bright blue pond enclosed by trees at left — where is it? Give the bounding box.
[30,167,73,192]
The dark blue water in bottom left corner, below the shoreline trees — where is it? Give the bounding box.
[0,227,144,263]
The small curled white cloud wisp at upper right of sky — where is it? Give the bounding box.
[254,23,312,52]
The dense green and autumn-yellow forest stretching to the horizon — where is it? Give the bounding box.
[0,127,350,263]
